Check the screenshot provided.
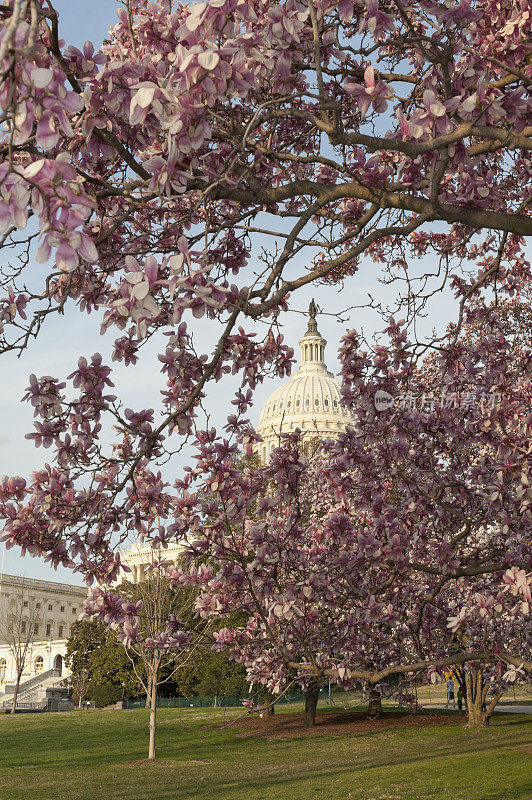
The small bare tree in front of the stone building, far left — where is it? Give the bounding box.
[0,583,41,714]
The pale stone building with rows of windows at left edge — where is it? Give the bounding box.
[0,574,87,694]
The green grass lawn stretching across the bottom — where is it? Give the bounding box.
[0,709,532,800]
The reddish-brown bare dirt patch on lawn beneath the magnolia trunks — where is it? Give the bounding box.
[235,711,464,739]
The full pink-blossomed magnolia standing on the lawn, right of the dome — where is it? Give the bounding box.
[167,290,532,725]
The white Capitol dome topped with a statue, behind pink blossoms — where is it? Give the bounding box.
[257,301,351,462]
